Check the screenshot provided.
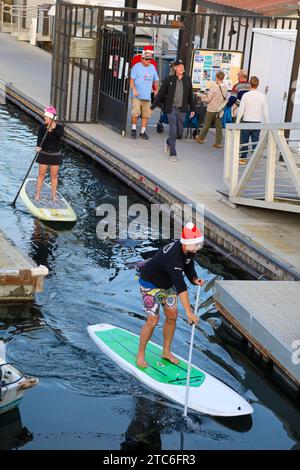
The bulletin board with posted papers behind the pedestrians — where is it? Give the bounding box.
[192,49,243,91]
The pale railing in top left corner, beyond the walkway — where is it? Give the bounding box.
[0,2,53,44]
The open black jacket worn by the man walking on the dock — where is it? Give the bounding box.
[151,75,195,113]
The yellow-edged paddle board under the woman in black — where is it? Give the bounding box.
[20,179,77,222]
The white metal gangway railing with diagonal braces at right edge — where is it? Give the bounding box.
[223,123,300,213]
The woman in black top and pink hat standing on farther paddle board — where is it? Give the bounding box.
[34,106,64,201]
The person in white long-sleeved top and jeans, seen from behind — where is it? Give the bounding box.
[236,76,269,165]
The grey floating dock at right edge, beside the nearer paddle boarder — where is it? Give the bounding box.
[214,281,300,390]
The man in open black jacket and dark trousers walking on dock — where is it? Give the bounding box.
[151,60,195,162]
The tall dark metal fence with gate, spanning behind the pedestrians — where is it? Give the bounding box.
[51,0,300,134]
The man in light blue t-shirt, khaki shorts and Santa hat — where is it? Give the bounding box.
[130,50,159,140]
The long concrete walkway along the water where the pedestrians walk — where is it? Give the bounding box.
[0,33,300,280]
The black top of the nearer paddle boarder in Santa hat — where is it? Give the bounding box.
[141,241,198,294]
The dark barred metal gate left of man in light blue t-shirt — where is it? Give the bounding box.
[97,28,134,135]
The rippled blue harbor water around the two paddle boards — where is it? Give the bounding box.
[0,105,300,451]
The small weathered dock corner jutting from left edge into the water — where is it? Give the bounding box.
[0,231,48,302]
